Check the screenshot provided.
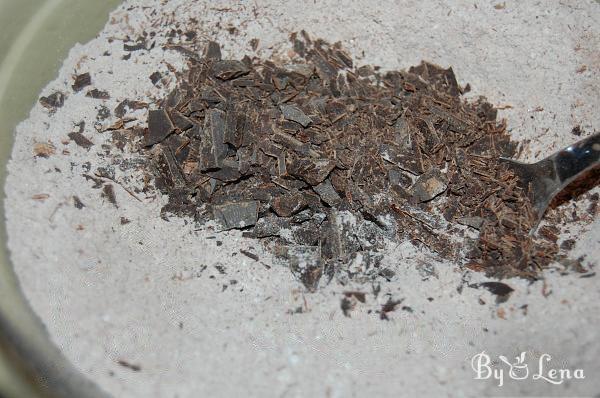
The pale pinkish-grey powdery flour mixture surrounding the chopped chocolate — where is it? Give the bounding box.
[6,0,600,397]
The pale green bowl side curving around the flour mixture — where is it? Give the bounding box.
[0,0,122,398]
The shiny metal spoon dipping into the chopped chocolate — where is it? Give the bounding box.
[500,133,600,233]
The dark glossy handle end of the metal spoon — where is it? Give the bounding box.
[550,133,600,187]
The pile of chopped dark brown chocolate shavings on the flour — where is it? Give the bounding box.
[134,33,557,289]
